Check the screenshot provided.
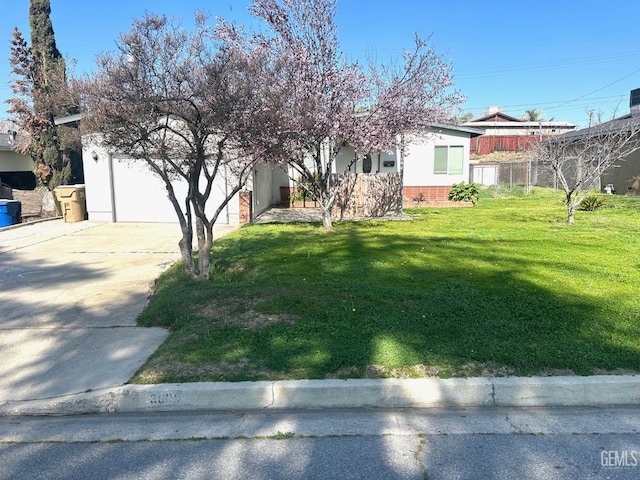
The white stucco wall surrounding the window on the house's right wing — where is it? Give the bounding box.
[404,129,471,186]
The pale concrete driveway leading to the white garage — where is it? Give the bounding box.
[0,220,232,404]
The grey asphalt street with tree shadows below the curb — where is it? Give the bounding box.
[0,406,640,480]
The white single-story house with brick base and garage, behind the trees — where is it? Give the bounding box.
[82,121,482,225]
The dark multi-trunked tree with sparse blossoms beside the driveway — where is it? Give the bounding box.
[78,15,272,279]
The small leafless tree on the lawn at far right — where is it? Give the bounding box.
[530,116,640,224]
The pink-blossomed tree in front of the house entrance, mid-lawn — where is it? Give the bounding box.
[224,0,462,229]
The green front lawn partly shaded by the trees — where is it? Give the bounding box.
[133,190,640,383]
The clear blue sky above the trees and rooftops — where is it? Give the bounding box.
[0,0,640,126]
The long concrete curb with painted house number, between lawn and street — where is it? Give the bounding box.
[0,375,640,416]
